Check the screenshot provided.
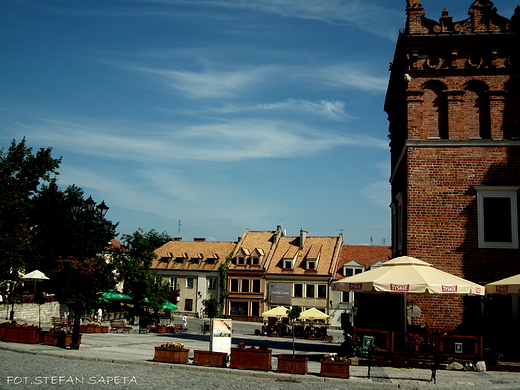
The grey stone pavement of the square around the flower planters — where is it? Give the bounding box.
[0,321,520,390]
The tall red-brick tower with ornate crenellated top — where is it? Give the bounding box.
[385,0,520,342]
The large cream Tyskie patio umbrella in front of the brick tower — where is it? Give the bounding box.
[332,256,485,330]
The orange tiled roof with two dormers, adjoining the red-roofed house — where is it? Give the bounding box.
[267,235,343,276]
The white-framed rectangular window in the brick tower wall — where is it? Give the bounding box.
[475,186,520,249]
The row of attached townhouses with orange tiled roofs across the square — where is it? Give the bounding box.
[150,226,388,327]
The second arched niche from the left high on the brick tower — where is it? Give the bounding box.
[462,81,491,139]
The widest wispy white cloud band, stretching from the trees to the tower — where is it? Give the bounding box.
[4,110,387,164]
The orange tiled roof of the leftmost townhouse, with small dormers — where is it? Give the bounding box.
[150,241,236,271]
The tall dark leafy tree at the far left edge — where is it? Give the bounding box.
[0,138,61,280]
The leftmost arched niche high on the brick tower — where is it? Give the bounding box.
[422,81,449,139]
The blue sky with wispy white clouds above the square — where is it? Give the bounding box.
[0,0,517,245]
